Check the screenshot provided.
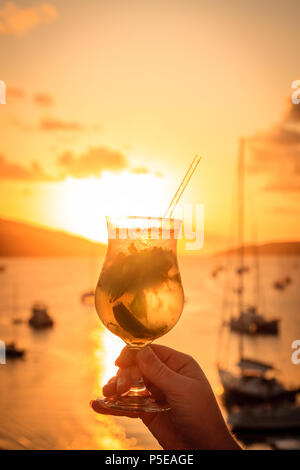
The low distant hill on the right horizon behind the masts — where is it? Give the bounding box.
[216,242,300,256]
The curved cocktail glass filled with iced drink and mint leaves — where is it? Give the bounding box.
[95,216,184,412]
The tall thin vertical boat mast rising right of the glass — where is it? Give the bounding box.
[238,137,245,361]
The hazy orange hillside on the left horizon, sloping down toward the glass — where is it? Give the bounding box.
[0,219,106,256]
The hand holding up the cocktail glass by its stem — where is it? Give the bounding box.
[91,345,240,450]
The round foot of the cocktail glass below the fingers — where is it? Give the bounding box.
[98,395,171,413]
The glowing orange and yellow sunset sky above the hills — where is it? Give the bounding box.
[0,0,300,251]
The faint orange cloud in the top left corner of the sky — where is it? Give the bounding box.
[0,2,58,35]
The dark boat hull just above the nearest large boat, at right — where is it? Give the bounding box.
[229,307,279,335]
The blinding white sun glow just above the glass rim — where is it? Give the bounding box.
[55,171,167,242]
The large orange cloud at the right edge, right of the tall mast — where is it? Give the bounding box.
[248,103,300,191]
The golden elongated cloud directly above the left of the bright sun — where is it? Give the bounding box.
[57,147,128,178]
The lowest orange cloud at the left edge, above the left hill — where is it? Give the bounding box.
[0,155,53,181]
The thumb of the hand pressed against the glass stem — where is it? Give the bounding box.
[136,346,181,395]
